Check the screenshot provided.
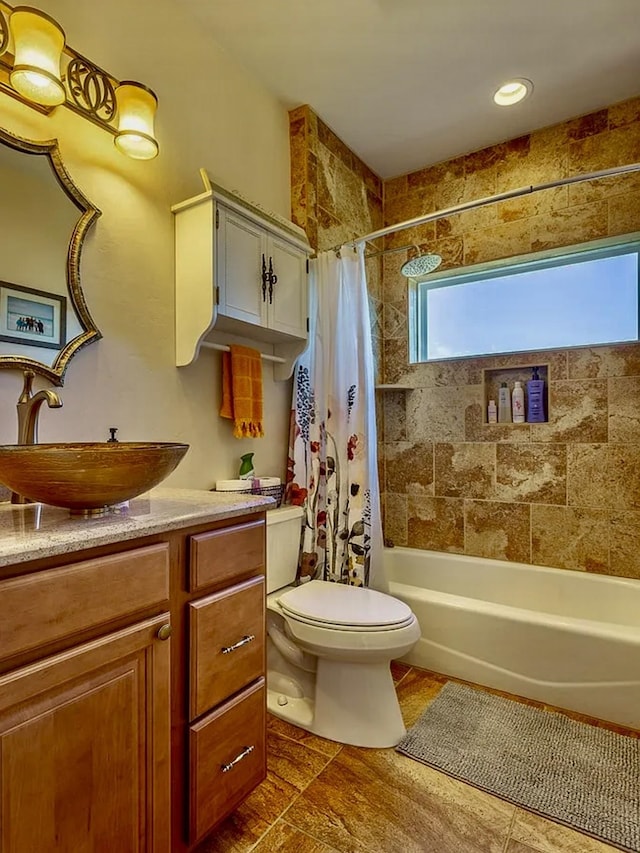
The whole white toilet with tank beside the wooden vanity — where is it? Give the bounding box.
[267,507,420,747]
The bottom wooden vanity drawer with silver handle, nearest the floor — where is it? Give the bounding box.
[189,678,267,843]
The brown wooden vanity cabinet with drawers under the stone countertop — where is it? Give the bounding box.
[0,490,266,853]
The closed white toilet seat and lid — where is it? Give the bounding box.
[278,580,415,632]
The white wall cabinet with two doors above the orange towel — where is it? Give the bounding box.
[172,173,311,377]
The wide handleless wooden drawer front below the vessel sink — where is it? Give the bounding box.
[0,542,169,658]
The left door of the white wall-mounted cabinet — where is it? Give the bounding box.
[216,205,268,326]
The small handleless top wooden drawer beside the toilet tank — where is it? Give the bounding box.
[189,521,265,592]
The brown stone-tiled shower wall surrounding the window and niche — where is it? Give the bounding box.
[291,98,640,577]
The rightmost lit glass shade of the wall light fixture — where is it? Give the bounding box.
[115,80,158,160]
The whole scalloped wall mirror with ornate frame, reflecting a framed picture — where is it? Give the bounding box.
[0,129,102,385]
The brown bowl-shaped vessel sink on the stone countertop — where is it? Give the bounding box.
[0,441,189,514]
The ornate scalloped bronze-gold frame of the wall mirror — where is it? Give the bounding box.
[0,128,102,385]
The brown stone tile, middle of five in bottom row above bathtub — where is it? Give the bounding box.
[464,500,531,563]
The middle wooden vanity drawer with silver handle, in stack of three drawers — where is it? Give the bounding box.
[189,576,265,720]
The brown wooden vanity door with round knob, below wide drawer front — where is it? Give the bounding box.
[0,614,170,853]
